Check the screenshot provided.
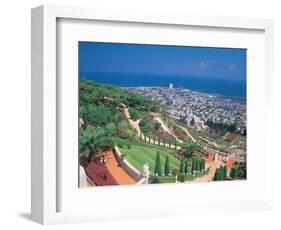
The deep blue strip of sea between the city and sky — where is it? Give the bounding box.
[80,72,246,99]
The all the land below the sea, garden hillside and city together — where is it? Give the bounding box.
[79,80,247,187]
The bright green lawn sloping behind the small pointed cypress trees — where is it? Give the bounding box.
[119,144,180,176]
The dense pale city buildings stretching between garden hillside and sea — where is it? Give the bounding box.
[126,83,246,132]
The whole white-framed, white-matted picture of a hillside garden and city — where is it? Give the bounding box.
[31,6,274,224]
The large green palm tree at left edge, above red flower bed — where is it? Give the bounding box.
[80,129,113,162]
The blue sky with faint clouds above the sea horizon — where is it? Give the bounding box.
[79,42,246,80]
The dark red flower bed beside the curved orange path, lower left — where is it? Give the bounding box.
[86,162,117,186]
